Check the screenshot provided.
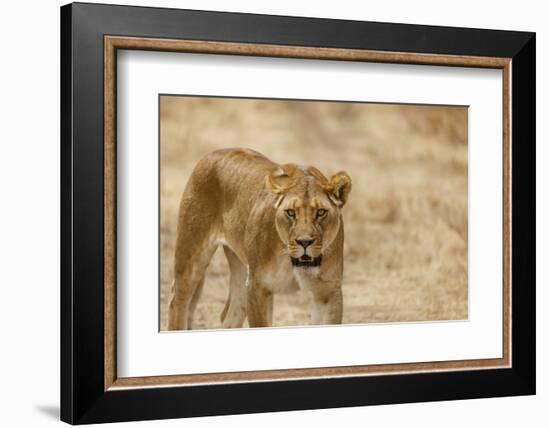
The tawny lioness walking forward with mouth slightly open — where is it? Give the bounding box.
[168,149,351,330]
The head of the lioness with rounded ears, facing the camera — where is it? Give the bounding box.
[266,164,351,267]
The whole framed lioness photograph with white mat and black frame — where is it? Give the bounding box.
[61,3,535,424]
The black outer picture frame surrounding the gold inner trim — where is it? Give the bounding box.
[61,3,536,424]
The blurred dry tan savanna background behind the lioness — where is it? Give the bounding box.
[160,96,468,330]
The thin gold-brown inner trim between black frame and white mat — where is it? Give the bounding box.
[104,36,512,391]
